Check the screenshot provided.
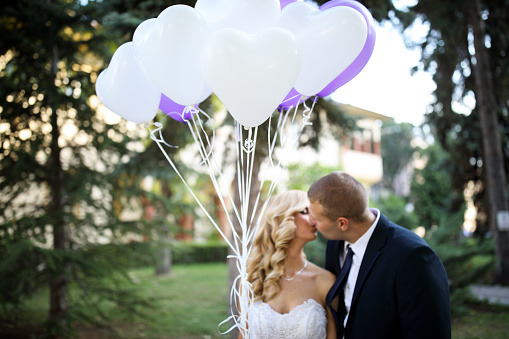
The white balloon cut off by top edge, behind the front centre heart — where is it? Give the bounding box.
[194,0,281,34]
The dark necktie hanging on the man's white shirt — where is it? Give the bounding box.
[326,246,353,338]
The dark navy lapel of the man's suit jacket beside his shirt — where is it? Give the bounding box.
[349,212,389,319]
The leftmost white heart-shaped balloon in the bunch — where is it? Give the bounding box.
[95,42,161,124]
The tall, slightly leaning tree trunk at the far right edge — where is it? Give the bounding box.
[468,0,509,285]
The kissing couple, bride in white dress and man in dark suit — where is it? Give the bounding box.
[239,172,451,339]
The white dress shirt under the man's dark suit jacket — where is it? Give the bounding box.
[340,208,380,326]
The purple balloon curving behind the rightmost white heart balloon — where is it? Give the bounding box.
[317,0,376,97]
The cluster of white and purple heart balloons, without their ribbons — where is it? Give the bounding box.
[96,0,375,127]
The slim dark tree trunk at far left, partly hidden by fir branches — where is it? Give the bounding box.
[48,46,69,338]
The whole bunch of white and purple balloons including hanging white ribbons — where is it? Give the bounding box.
[96,0,375,338]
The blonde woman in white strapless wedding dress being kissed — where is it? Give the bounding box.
[239,190,337,339]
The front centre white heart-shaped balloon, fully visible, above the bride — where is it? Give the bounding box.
[202,27,302,127]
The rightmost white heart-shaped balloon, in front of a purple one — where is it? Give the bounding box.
[279,2,368,96]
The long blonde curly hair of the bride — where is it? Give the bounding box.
[247,190,309,302]
